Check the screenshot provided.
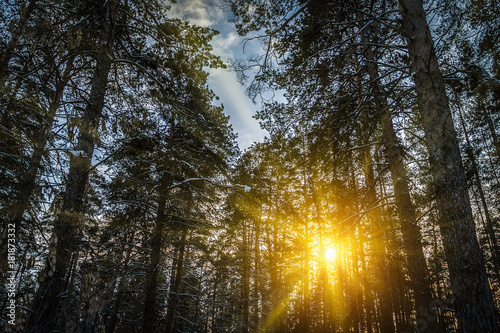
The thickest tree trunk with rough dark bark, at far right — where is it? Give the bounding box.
[399,0,500,332]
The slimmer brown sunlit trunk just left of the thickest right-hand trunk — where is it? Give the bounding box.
[357,11,438,332]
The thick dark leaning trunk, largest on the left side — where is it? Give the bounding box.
[27,1,119,332]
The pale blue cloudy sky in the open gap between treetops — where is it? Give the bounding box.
[168,0,267,150]
